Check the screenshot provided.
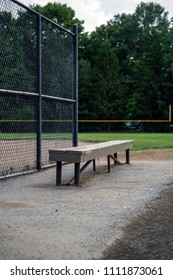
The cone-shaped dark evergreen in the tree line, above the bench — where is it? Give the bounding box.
[91,39,123,120]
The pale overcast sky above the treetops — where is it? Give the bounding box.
[19,0,173,32]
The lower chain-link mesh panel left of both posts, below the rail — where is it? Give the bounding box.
[0,94,36,176]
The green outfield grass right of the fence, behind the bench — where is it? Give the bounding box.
[79,132,173,150]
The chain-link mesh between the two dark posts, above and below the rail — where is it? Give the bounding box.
[42,18,73,164]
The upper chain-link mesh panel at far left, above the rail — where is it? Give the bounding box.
[0,0,36,92]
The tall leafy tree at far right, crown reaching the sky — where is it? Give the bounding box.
[129,3,170,124]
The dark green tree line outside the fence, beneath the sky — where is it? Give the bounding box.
[0,2,173,131]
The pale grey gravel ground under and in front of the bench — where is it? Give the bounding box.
[0,150,173,260]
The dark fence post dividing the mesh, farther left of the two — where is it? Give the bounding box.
[36,15,42,170]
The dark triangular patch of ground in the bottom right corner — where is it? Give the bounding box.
[103,184,173,260]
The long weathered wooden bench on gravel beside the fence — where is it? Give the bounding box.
[49,140,133,186]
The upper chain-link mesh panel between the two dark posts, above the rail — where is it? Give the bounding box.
[42,18,73,99]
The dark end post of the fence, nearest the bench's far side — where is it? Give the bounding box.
[73,24,78,146]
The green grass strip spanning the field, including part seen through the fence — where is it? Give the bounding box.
[0,132,173,150]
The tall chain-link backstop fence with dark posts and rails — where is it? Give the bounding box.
[0,0,78,179]
